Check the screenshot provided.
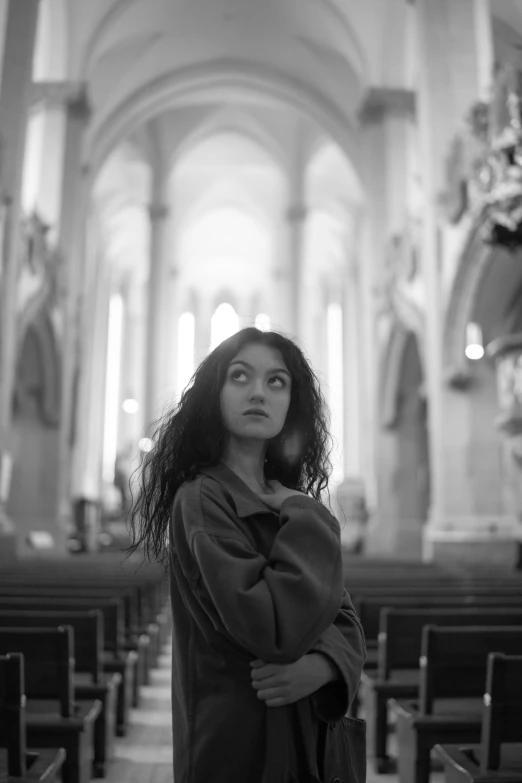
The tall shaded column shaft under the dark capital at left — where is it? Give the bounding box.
[57,95,90,529]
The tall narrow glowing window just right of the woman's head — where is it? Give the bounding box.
[327,303,344,481]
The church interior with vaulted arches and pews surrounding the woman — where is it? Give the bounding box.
[0,0,522,783]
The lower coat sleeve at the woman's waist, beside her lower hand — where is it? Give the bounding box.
[309,589,366,721]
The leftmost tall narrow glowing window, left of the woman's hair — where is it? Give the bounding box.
[103,294,123,484]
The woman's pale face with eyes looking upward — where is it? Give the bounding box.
[220,343,292,440]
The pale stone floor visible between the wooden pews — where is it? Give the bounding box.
[100,647,444,783]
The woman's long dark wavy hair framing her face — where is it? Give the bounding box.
[127,327,331,564]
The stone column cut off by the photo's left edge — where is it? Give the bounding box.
[0,0,38,552]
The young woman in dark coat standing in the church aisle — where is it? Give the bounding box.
[131,328,365,783]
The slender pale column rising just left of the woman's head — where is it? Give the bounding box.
[145,202,170,434]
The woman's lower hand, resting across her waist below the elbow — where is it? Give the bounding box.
[250,653,334,707]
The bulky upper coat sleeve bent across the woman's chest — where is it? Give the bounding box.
[181,481,343,663]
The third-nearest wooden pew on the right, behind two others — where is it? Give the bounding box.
[361,607,522,774]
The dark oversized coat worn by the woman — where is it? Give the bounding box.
[170,465,365,783]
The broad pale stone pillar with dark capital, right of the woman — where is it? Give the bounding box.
[356,89,425,559]
